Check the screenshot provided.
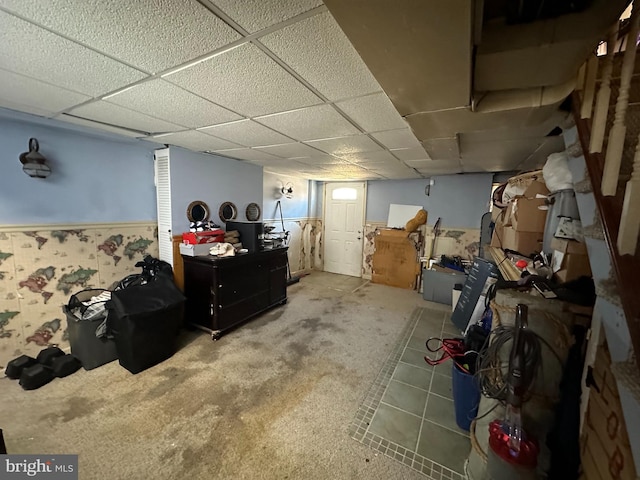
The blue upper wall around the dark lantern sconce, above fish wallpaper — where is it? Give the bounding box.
[0,110,157,225]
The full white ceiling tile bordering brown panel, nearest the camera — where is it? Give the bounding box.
[260,12,382,100]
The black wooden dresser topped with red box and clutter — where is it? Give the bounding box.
[182,247,287,340]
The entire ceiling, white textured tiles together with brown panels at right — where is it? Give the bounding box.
[0,0,626,180]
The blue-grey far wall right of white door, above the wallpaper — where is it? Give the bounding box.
[366,173,493,228]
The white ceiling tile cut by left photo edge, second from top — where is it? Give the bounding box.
[0,10,145,96]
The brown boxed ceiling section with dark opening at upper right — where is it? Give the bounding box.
[325,0,629,171]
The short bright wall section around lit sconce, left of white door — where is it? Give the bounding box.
[262,172,313,220]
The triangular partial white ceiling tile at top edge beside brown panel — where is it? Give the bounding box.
[214,0,322,33]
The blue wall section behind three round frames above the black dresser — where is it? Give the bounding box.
[169,147,264,235]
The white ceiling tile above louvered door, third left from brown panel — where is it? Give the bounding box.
[105,80,242,128]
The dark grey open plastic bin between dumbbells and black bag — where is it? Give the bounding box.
[62,305,118,370]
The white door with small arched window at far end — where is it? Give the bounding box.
[324,182,367,277]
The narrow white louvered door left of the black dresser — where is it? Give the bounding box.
[154,148,173,265]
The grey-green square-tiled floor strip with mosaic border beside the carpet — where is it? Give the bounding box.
[349,308,471,480]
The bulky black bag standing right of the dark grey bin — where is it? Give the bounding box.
[107,275,185,373]
